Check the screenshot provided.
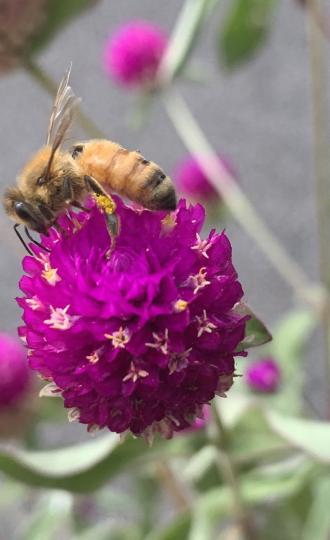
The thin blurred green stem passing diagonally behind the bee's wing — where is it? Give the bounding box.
[23,58,107,139]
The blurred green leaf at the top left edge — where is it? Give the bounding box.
[26,0,98,56]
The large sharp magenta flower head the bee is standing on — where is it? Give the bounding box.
[18,199,246,438]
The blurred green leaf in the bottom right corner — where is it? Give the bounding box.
[301,476,330,540]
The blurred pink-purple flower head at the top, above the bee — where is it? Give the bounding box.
[103,20,167,87]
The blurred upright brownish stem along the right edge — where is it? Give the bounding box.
[307,0,330,418]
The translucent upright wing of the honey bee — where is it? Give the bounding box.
[47,65,81,152]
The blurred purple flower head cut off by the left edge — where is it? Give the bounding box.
[0,333,30,410]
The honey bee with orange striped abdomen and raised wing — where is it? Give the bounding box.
[3,68,176,253]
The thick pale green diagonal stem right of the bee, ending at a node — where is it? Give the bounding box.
[163,90,328,313]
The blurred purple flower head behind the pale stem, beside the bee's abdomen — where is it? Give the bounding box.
[173,155,236,203]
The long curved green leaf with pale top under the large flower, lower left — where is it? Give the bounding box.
[0,434,189,492]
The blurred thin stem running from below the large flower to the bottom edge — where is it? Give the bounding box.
[210,402,257,540]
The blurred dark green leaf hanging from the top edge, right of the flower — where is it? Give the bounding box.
[219,0,277,69]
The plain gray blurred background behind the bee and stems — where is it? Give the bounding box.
[0,0,322,394]
